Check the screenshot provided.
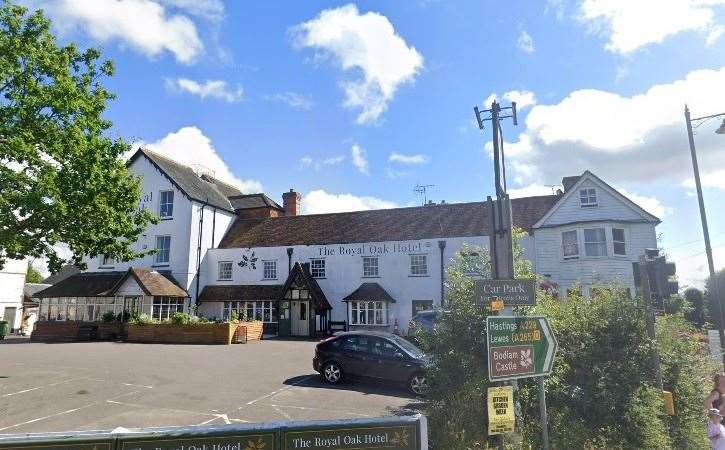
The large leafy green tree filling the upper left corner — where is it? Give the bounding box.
[0,0,154,271]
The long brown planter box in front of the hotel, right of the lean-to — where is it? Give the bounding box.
[126,323,237,345]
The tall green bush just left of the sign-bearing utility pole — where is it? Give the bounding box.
[416,232,533,450]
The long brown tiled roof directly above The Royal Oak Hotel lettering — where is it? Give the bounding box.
[219,195,560,248]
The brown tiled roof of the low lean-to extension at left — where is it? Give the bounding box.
[33,268,188,298]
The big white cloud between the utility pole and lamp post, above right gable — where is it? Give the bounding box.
[505,68,725,185]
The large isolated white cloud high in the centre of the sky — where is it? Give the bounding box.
[292,4,423,124]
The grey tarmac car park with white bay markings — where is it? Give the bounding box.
[0,338,417,434]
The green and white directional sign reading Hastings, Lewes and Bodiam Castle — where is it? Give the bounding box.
[486,316,557,381]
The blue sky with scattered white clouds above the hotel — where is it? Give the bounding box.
[25,0,725,284]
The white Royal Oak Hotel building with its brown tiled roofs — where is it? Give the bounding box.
[36,150,659,336]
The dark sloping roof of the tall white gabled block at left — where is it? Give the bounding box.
[128,148,235,211]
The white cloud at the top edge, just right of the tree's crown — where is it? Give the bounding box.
[39,0,204,64]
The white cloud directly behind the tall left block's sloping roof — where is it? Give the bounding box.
[139,126,262,193]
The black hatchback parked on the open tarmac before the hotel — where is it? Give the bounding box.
[312,331,428,395]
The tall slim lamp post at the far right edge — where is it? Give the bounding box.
[685,105,725,367]
